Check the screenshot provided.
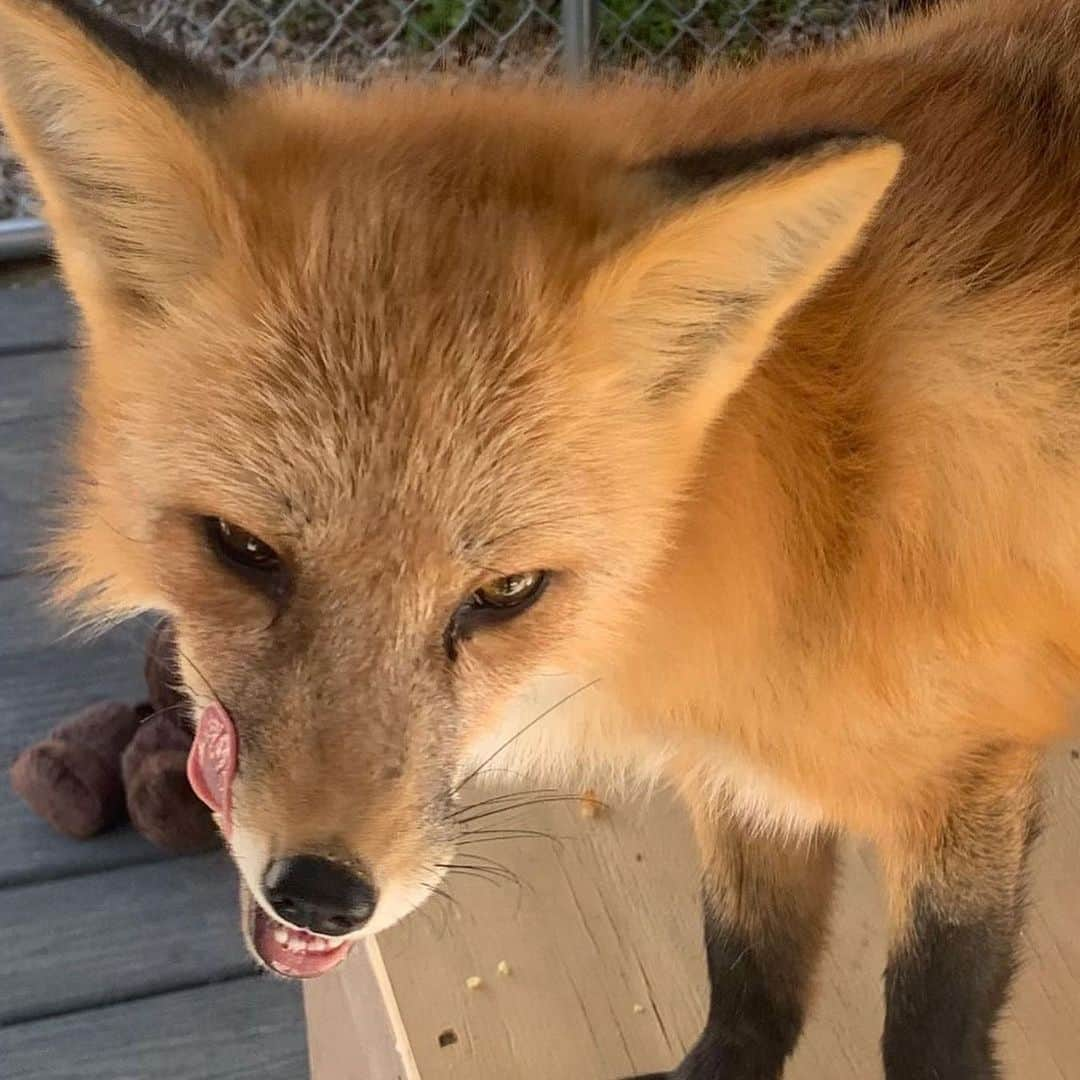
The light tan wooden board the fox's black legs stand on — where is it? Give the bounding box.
[309,751,1080,1080]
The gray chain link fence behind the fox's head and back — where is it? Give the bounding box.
[0,0,896,218]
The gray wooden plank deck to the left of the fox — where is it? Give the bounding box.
[0,274,309,1080]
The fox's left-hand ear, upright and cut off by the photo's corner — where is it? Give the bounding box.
[0,0,229,303]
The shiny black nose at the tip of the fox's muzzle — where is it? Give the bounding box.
[262,855,376,937]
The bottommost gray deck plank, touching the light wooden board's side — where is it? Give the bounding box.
[0,976,308,1080]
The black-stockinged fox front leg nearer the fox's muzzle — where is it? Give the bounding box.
[638,808,836,1080]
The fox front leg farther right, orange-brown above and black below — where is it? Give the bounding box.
[881,748,1040,1080]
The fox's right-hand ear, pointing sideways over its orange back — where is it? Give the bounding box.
[584,135,903,404]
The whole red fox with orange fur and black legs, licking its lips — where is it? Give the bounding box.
[0,0,1080,1080]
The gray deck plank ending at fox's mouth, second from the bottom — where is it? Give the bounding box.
[0,853,254,1025]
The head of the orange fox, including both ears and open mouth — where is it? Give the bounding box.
[0,0,901,974]
